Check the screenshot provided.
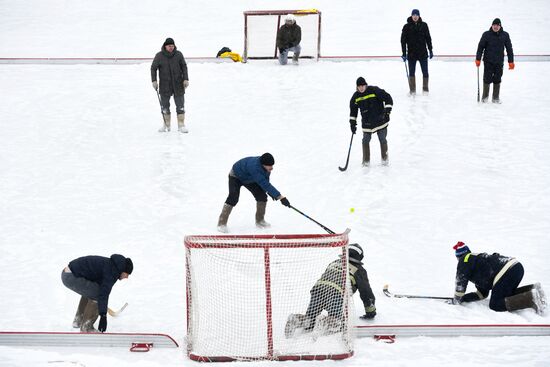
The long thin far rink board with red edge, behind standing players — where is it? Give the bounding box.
[0,54,550,65]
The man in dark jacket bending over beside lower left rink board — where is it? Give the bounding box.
[61,254,134,333]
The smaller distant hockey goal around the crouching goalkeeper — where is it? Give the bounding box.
[243,9,321,62]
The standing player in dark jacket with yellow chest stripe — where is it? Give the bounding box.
[349,77,393,167]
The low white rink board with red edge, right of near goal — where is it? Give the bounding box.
[354,324,550,338]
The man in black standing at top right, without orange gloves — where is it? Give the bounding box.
[401,9,434,95]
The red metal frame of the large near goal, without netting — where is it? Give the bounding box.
[184,229,353,362]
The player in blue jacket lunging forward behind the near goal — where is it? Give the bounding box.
[218,153,290,233]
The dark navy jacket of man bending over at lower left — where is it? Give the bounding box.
[69,254,126,315]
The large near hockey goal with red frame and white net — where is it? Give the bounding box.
[185,231,353,362]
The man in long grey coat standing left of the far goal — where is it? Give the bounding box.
[151,38,189,133]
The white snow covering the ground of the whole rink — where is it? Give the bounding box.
[0,0,550,366]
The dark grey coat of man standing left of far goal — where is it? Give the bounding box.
[151,45,189,96]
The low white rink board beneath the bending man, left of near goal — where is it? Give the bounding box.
[0,331,179,348]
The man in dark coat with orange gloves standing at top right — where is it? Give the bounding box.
[476,18,515,103]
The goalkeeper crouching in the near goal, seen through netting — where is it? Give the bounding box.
[285,243,376,338]
